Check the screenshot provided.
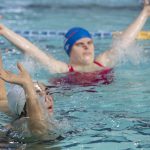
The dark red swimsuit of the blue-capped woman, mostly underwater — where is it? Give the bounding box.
[50,61,113,86]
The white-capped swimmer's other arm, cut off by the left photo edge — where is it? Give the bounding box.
[0,54,9,113]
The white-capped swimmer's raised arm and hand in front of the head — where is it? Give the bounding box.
[0,63,48,138]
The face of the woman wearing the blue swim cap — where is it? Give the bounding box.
[70,38,94,65]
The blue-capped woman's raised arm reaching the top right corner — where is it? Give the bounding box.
[96,0,150,67]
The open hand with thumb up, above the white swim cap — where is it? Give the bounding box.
[0,62,32,86]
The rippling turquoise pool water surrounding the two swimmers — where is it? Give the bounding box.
[0,0,150,150]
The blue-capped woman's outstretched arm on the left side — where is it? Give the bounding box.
[0,24,68,73]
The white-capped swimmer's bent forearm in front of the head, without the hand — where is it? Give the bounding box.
[24,82,48,136]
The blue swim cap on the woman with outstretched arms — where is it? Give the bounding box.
[64,27,92,55]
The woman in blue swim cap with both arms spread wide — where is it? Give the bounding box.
[0,0,150,73]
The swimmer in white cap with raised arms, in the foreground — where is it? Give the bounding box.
[0,54,57,140]
